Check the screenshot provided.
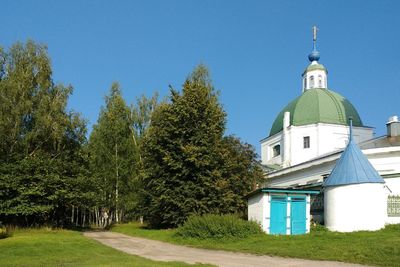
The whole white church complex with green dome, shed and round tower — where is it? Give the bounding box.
[248,27,400,234]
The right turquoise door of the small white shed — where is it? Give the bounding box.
[290,197,306,235]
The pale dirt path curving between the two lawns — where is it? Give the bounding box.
[84,232,362,267]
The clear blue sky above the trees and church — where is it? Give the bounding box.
[0,0,400,155]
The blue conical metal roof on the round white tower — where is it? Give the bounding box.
[323,123,385,187]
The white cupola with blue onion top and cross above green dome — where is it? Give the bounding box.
[302,26,328,93]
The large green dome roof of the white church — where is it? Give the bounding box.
[269,88,363,136]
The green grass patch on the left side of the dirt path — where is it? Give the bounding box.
[0,229,211,266]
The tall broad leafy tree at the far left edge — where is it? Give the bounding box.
[0,41,87,225]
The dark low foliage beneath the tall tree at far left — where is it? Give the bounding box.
[0,155,94,225]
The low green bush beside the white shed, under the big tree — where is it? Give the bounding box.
[176,214,262,239]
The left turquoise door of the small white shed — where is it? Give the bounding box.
[269,196,287,235]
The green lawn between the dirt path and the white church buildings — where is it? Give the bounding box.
[112,223,400,266]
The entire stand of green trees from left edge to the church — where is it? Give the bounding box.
[0,41,262,227]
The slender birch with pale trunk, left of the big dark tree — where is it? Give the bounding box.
[89,83,138,222]
